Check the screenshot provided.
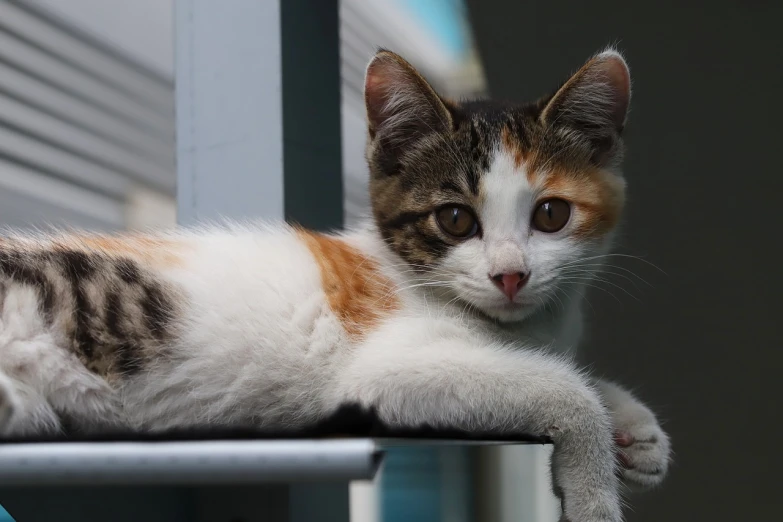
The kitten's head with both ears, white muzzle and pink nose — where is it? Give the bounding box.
[365,47,630,321]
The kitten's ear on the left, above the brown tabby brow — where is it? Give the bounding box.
[364,50,452,143]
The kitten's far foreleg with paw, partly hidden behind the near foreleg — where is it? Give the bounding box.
[597,381,671,489]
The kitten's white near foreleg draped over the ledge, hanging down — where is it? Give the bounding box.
[330,319,622,522]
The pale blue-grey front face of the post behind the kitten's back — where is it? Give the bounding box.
[175,0,284,224]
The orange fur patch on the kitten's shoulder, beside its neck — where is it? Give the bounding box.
[298,230,400,339]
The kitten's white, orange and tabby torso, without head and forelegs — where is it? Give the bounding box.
[0,221,579,428]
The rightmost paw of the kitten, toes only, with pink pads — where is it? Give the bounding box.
[615,420,671,489]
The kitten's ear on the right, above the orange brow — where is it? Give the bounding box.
[540,50,631,160]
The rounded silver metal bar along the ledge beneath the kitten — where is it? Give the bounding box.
[0,439,382,487]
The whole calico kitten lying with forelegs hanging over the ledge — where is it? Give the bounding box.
[0,50,670,522]
